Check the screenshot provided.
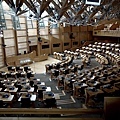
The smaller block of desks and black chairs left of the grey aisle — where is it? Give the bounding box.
[0,66,59,108]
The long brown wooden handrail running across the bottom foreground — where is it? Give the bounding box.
[0,108,103,115]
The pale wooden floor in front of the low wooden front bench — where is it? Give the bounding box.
[0,57,59,73]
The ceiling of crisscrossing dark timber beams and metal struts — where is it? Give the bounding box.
[1,0,120,25]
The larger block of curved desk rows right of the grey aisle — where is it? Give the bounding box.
[47,42,120,106]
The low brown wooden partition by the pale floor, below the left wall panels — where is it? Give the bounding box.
[6,51,36,66]
